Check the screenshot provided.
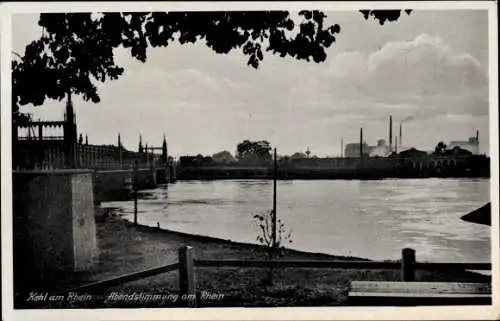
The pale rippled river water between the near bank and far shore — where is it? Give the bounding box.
[103,179,490,262]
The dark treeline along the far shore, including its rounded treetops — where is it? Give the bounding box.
[177,140,490,180]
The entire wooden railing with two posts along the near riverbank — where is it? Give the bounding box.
[59,246,491,307]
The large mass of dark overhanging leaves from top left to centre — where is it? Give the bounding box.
[13,11,364,108]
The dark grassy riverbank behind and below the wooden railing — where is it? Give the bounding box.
[21,210,490,308]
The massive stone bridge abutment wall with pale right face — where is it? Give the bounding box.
[13,170,97,279]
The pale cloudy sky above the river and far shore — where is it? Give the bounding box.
[12,10,489,157]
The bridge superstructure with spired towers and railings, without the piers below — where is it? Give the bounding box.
[12,94,174,178]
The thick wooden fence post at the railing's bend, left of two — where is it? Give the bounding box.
[179,246,197,307]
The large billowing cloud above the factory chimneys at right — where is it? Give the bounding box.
[291,34,488,123]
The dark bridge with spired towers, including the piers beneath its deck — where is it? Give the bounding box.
[12,95,177,203]
